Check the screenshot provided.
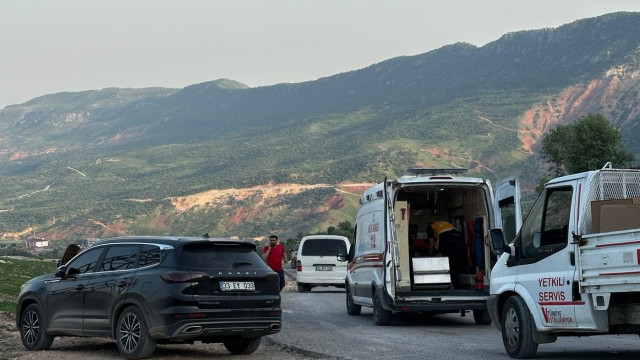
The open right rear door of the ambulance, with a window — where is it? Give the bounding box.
[493,176,522,243]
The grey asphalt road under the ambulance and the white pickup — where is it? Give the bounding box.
[278,268,640,360]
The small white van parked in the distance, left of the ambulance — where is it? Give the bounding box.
[296,235,351,292]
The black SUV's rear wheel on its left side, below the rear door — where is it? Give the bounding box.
[116,306,156,359]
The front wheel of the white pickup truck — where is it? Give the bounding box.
[501,296,538,359]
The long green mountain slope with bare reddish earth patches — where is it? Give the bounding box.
[0,13,640,240]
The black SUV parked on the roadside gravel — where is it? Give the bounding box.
[16,237,282,359]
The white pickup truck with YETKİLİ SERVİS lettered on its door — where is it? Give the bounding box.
[488,164,640,359]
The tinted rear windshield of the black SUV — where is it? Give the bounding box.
[180,243,266,269]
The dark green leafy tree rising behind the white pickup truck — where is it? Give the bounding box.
[542,114,634,176]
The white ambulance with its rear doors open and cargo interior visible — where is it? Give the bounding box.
[338,168,521,325]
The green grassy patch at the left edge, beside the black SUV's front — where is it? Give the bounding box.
[0,257,56,314]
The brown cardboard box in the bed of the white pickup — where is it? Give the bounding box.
[591,198,640,233]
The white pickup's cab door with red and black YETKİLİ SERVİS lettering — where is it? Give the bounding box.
[507,184,581,327]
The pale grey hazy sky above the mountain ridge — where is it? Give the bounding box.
[0,0,640,109]
